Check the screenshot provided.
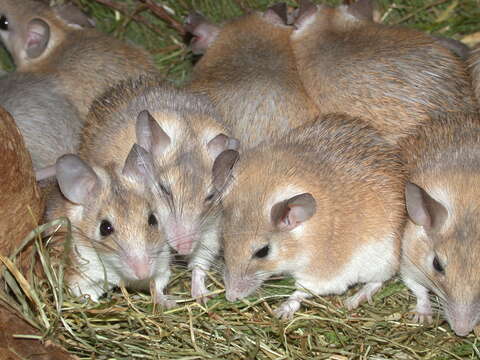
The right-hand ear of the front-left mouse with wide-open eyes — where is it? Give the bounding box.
[122,144,153,183]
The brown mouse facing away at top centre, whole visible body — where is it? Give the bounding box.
[186,4,318,148]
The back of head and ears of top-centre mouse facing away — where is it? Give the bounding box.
[185,3,287,54]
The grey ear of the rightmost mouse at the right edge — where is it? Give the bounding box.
[405,182,448,230]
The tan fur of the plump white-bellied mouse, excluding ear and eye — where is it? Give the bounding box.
[224,114,405,306]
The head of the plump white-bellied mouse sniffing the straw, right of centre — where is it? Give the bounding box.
[217,153,317,301]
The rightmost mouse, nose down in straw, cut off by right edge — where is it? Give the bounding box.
[401,113,480,336]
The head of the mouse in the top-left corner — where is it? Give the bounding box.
[0,0,94,71]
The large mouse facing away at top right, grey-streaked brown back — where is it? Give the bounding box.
[290,0,478,142]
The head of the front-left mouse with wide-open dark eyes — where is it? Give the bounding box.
[56,145,168,281]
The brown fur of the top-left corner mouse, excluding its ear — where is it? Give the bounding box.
[0,0,156,117]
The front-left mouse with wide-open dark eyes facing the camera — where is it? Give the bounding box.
[48,144,175,307]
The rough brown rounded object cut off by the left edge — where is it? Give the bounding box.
[0,108,43,266]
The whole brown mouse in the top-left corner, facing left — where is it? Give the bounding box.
[0,0,155,118]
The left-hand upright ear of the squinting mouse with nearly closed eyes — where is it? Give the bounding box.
[135,110,171,158]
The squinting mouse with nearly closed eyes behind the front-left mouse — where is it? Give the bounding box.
[81,78,239,300]
